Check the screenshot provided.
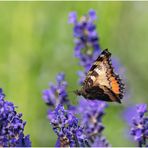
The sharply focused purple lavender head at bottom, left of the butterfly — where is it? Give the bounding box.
[48,105,87,147]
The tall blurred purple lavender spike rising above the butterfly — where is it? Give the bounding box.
[69,9,100,71]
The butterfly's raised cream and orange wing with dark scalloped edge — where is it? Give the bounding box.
[84,49,124,102]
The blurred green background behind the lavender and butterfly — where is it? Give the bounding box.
[0,2,148,146]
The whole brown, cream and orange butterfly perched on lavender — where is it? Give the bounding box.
[75,49,124,103]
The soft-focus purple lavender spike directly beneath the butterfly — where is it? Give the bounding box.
[78,99,109,147]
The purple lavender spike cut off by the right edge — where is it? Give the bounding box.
[130,104,148,147]
